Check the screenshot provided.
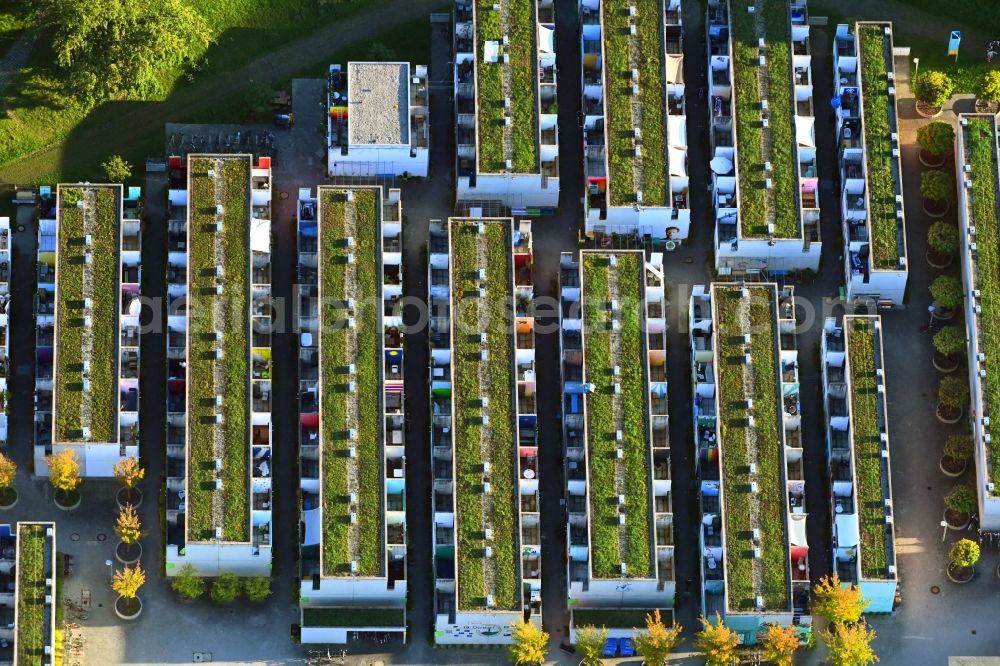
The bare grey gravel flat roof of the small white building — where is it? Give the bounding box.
[347,62,410,146]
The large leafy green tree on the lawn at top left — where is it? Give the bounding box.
[33,0,212,106]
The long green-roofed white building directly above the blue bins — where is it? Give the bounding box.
[559,250,676,640]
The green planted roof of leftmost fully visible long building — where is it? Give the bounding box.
[54,187,120,442]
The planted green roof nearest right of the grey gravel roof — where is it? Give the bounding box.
[476,0,538,173]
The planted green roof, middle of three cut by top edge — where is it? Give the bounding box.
[603,0,667,206]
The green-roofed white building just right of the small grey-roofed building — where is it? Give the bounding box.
[454,0,559,208]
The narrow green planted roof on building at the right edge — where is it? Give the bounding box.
[965,118,1000,484]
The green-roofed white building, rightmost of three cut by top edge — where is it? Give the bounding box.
[706,0,820,278]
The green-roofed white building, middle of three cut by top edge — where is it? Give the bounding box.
[580,0,691,243]
